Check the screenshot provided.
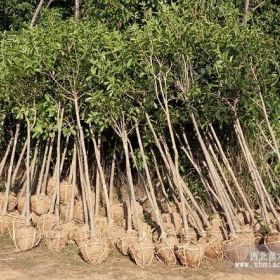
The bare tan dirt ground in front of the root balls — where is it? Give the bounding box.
[0,236,280,280]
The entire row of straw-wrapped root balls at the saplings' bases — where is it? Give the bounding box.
[0,178,280,267]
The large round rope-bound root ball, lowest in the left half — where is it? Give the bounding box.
[79,236,109,264]
